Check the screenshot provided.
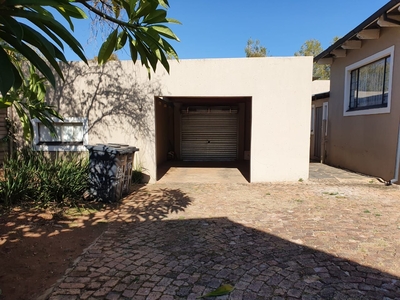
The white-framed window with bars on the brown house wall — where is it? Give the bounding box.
[344,47,394,116]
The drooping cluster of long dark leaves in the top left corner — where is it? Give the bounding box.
[0,0,86,97]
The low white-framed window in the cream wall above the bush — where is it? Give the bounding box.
[33,118,88,151]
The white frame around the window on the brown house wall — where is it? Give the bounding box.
[343,46,394,117]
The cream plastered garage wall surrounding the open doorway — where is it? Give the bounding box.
[44,57,312,182]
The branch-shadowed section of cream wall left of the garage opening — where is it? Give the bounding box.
[41,61,159,179]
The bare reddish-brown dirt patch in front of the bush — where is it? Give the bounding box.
[0,204,116,300]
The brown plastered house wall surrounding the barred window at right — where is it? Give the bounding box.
[326,28,400,180]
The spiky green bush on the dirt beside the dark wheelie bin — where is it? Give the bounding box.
[0,148,89,206]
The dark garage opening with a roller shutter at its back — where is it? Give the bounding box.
[155,96,251,182]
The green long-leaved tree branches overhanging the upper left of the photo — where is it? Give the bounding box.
[0,0,179,140]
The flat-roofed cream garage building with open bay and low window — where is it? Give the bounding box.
[34,57,312,182]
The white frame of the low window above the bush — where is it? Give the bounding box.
[32,117,89,152]
